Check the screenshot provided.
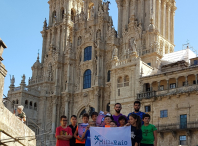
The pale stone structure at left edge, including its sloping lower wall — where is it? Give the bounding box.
[0,39,36,146]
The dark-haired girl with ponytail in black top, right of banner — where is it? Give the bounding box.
[127,114,142,146]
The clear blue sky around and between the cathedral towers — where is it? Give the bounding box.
[0,0,198,95]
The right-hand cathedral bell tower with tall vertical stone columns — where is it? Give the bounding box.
[116,0,176,68]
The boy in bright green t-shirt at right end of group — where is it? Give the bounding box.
[140,114,157,146]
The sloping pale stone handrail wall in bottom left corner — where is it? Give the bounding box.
[0,103,36,146]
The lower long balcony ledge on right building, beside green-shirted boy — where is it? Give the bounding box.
[156,121,198,132]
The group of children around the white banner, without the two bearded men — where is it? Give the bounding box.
[56,102,157,146]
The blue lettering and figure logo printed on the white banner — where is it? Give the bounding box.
[94,135,128,146]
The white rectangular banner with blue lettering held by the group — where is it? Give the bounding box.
[90,126,131,146]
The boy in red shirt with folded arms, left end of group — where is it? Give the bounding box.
[55,116,72,146]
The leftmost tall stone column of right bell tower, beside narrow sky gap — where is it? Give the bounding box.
[116,0,123,37]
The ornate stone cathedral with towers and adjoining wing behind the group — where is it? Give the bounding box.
[6,0,198,146]
